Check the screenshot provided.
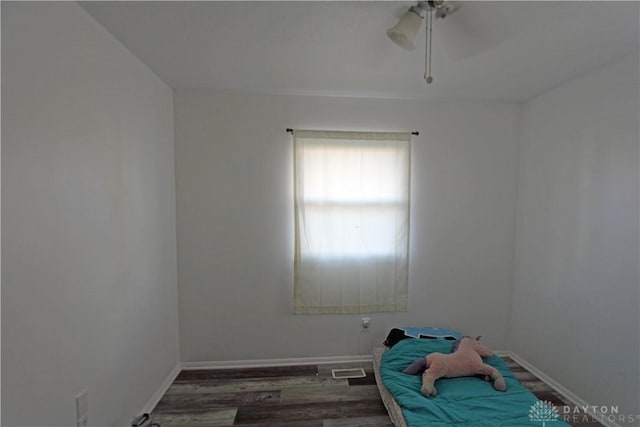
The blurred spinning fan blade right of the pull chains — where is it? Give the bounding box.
[433,2,513,60]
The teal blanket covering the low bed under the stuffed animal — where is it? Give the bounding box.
[380,339,568,427]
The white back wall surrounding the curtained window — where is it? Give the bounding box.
[174,90,519,362]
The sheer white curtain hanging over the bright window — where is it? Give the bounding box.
[294,130,411,314]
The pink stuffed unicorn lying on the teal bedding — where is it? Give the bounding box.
[420,337,507,397]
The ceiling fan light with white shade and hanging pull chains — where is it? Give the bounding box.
[387,0,460,84]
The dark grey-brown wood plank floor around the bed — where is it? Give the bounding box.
[151,358,601,427]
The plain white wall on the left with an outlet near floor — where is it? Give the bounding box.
[2,2,178,426]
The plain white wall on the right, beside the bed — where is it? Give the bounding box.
[510,54,640,425]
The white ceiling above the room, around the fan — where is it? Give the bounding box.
[81,1,640,101]
